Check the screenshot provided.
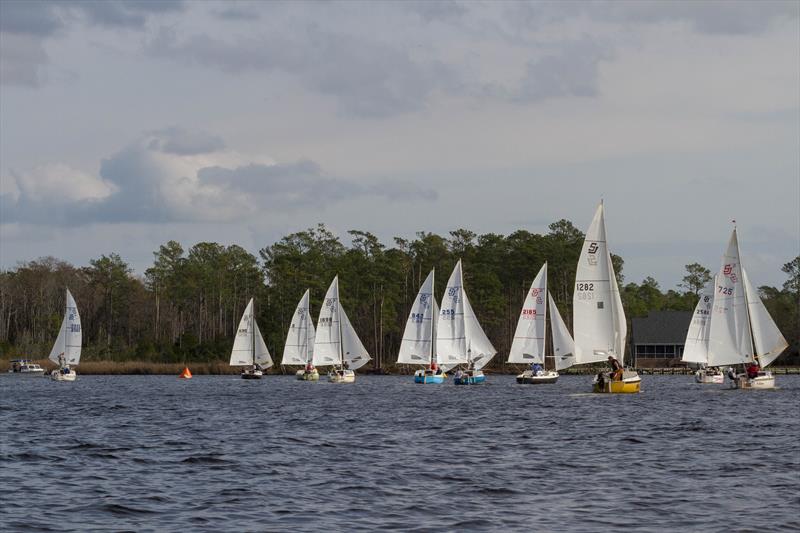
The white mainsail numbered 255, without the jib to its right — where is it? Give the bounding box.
[436,259,469,368]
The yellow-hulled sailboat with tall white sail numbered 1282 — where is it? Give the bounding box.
[572,202,641,393]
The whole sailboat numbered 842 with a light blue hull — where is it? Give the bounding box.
[397,270,448,383]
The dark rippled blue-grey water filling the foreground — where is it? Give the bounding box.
[0,375,800,532]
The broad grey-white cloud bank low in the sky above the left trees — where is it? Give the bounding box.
[0,127,436,225]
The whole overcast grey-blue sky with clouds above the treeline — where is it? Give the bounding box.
[0,0,800,289]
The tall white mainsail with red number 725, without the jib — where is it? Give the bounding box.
[708,229,753,366]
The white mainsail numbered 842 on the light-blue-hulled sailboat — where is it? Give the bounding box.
[397,270,438,365]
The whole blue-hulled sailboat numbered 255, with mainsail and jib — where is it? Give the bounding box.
[436,259,497,385]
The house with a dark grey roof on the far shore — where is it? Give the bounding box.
[630,311,692,368]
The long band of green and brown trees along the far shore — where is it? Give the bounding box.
[0,220,800,368]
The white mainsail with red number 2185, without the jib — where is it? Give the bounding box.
[508,263,547,364]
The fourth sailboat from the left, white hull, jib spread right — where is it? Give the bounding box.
[313,276,371,383]
